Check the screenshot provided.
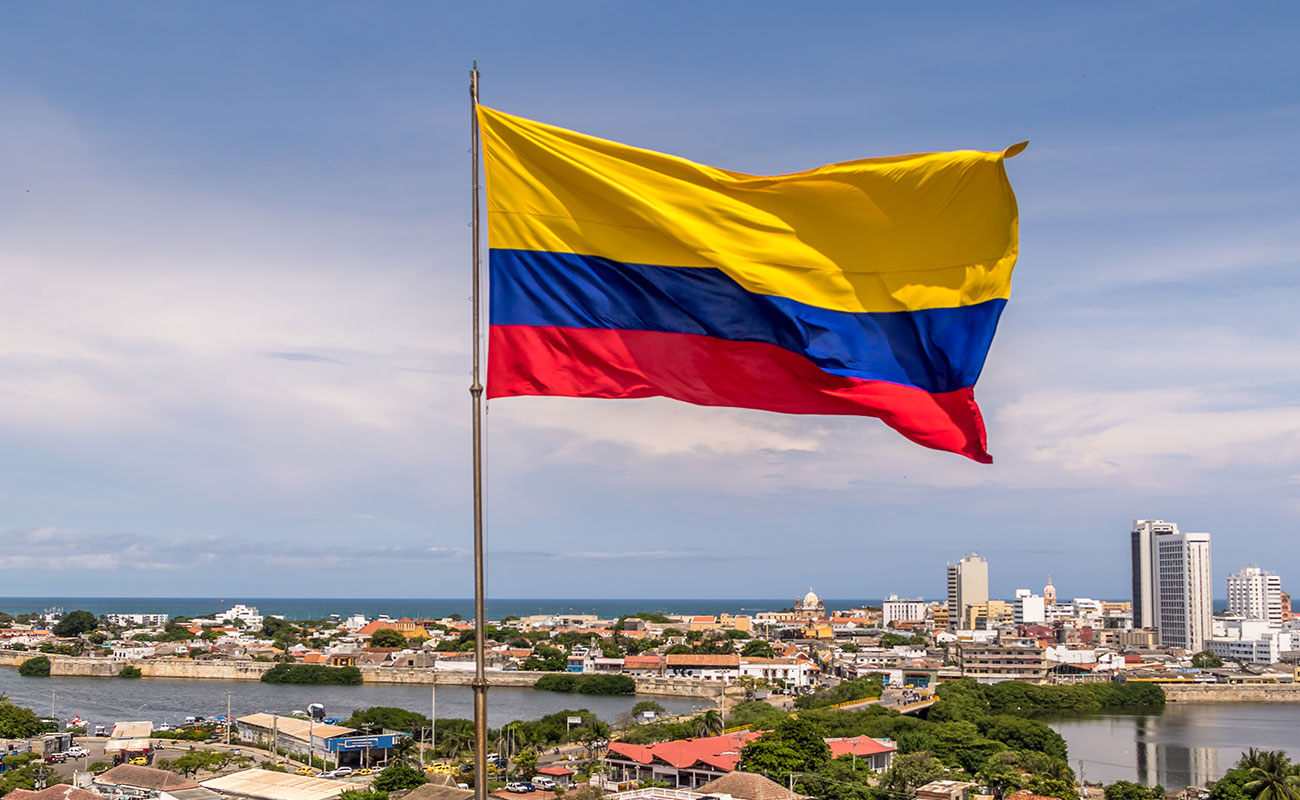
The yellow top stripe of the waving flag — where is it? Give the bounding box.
[478,107,1023,312]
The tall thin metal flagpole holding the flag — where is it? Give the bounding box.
[469,61,488,800]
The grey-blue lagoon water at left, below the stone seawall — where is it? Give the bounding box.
[0,667,712,727]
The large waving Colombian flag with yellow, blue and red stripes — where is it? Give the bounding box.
[478,105,1024,463]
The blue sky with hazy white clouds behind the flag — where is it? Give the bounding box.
[0,3,1300,597]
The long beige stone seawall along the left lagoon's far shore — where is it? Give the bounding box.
[0,650,720,699]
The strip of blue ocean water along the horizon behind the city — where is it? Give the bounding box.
[0,597,880,619]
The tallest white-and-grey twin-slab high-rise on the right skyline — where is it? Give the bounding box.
[1131,519,1213,652]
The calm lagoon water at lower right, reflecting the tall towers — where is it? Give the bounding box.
[1044,702,1300,788]
